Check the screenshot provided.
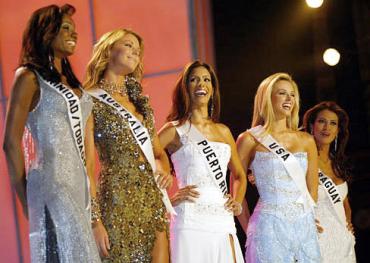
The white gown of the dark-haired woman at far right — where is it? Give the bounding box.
[315,182,356,263]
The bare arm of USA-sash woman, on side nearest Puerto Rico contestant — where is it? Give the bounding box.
[236,132,256,231]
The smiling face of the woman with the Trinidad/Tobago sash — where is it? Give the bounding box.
[51,15,77,58]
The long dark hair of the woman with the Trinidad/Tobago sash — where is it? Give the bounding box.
[19,4,80,88]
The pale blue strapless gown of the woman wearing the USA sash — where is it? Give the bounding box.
[245,152,320,263]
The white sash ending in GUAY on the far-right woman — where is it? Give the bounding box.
[319,170,347,226]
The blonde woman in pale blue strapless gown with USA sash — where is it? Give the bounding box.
[237,73,320,263]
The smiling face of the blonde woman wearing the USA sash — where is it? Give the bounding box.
[271,80,296,119]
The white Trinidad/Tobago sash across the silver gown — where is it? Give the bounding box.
[37,74,90,210]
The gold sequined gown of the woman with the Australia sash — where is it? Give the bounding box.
[93,97,168,263]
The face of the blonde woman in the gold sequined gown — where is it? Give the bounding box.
[108,34,141,75]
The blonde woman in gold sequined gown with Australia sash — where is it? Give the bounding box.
[84,29,172,263]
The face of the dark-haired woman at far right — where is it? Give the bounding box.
[312,110,339,145]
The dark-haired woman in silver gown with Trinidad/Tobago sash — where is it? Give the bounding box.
[4,5,100,262]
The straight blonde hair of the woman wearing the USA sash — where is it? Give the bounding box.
[252,73,299,132]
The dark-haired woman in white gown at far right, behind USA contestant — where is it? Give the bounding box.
[303,101,356,263]
